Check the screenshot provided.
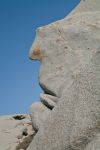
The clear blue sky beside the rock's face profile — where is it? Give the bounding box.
[0,0,80,115]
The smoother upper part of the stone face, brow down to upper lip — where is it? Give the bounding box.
[30,12,100,97]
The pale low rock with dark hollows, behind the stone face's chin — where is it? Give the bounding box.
[0,114,35,150]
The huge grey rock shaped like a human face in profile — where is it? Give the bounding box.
[28,0,100,150]
